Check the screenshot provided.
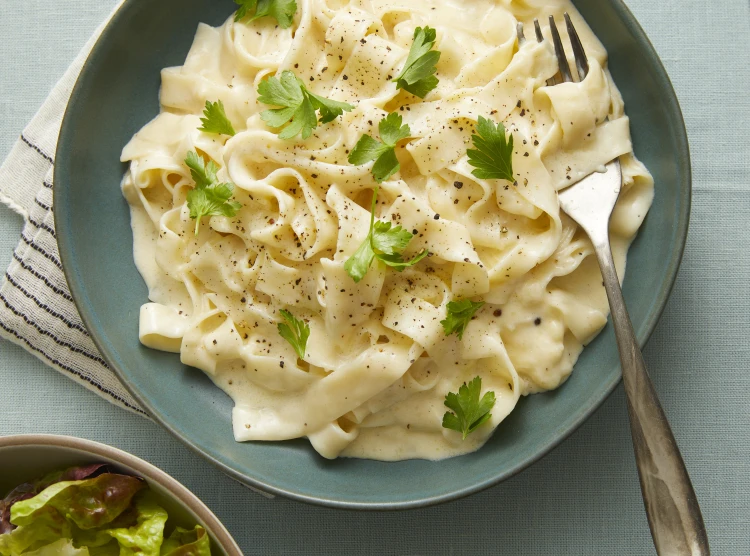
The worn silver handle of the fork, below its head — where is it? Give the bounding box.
[595,241,710,556]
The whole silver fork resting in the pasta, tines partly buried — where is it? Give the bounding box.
[518,13,710,556]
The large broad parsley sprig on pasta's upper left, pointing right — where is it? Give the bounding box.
[258,70,354,139]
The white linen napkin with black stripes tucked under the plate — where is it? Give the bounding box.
[0,2,145,415]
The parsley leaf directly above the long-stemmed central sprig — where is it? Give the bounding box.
[349,112,411,183]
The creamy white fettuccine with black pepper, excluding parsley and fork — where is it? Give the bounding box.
[122,0,653,460]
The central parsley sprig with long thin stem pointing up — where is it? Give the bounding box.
[344,188,429,282]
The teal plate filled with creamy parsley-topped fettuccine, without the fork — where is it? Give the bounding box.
[55,0,690,509]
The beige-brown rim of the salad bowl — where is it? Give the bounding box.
[0,434,242,556]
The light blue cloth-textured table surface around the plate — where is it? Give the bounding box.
[0,0,750,556]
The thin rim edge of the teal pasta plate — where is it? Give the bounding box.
[53,0,692,510]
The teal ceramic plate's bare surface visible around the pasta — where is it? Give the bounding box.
[55,0,690,509]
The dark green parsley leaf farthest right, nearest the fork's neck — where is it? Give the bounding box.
[466,116,515,182]
